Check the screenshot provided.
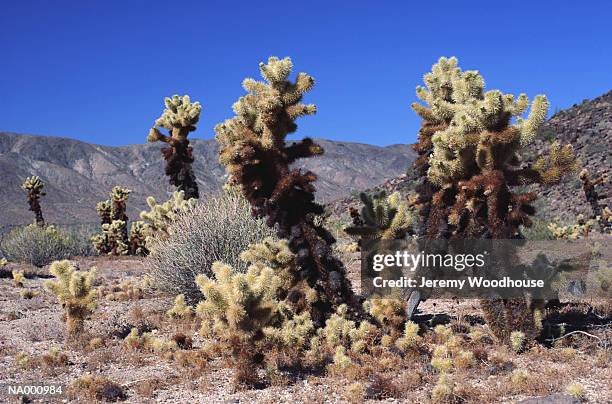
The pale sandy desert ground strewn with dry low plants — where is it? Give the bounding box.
[0,257,612,403]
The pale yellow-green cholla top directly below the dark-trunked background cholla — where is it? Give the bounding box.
[140,191,197,243]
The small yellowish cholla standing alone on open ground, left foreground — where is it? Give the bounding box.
[45,260,97,338]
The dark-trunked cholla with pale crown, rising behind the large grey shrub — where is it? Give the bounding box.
[147,95,202,199]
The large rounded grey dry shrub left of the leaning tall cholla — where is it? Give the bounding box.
[148,192,273,304]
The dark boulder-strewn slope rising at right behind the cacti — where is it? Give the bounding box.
[330,91,612,223]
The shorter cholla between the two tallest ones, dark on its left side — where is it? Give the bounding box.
[344,191,416,244]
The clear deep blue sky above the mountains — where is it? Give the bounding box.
[0,0,612,145]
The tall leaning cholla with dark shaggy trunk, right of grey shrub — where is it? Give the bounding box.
[215,57,353,322]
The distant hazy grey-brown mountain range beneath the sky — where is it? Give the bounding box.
[0,132,414,225]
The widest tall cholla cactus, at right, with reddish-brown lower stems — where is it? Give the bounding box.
[413,58,576,340]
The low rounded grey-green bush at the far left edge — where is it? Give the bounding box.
[0,224,91,267]
